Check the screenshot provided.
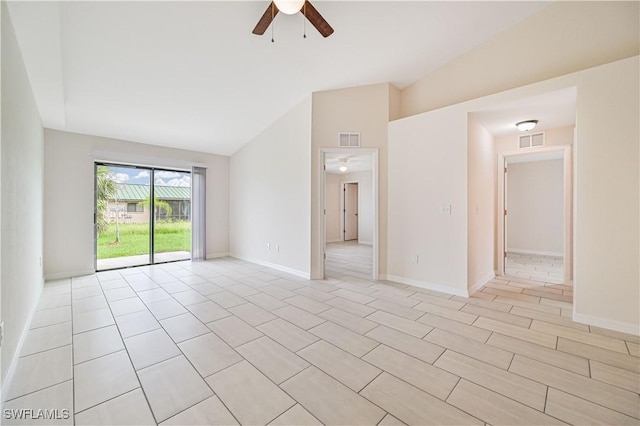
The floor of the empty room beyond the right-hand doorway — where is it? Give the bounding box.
[504,252,564,284]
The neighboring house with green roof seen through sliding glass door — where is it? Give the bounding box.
[107,184,191,223]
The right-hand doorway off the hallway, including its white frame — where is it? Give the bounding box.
[498,146,571,284]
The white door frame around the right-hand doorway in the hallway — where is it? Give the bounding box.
[496,145,573,284]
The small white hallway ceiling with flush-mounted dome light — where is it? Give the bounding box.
[472,87,577,136]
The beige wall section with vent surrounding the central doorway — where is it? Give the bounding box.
[311,83,390,278]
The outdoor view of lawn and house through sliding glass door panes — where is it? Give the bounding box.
[96,165,191,270]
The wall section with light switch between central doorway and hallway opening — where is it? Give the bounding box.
[387,108,468,295]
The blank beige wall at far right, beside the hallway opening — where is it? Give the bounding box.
[574,56,640,334]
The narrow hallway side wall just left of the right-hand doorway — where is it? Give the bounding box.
[467,115,496,292]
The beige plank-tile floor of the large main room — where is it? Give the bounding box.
[3,258,640,425]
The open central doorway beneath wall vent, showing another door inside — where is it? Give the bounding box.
[323,149,377,280]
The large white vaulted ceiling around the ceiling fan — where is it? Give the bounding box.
[9,0,548,155]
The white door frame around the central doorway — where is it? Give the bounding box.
[318,148,380,280]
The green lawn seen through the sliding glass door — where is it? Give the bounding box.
[98,221,191,259]
